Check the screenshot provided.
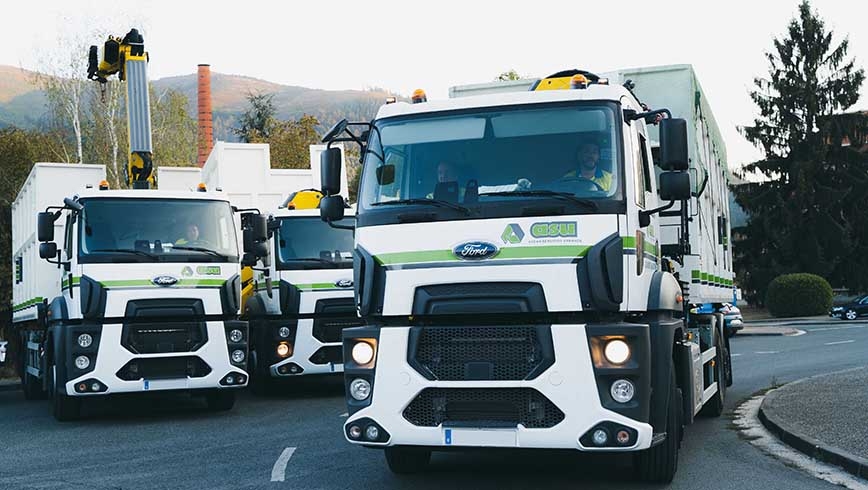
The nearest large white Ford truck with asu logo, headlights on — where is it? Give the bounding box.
[320,66,732,482]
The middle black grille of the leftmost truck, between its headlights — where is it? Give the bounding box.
[121,322,208,354]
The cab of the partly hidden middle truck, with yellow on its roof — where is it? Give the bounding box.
[244,201,360,392]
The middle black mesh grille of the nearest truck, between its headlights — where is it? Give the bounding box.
[409,326,554,381]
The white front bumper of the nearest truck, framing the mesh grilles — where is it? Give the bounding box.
[344,325,653,451]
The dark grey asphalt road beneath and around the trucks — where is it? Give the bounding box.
[0,320,868,490]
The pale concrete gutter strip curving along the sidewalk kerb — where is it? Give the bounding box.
[733,395,868,490]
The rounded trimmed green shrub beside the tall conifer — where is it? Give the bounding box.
[766,274,832,317]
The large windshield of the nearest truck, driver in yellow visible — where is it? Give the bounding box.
[359,102,623,221]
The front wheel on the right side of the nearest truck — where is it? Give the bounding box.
[633,363,684,483]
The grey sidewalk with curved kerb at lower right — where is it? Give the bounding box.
[759,367,868,479]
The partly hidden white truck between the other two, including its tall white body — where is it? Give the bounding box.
[157,142,359,393]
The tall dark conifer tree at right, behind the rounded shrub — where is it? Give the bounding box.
[733,1,868,304]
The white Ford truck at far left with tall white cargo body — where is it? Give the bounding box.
[12,163,267,420]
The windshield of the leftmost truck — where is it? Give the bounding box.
[79,198,238,263]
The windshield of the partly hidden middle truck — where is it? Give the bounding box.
[276,216,353,270]
